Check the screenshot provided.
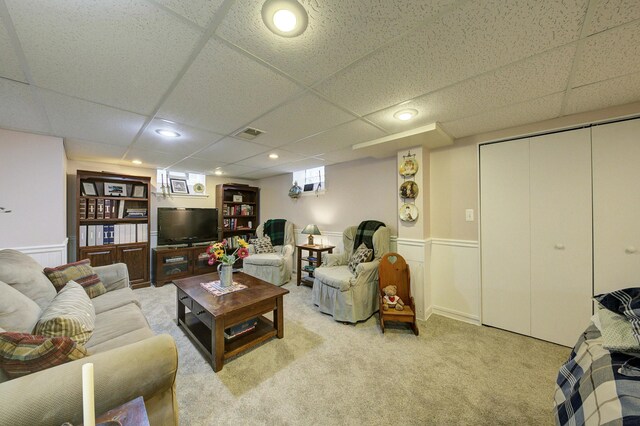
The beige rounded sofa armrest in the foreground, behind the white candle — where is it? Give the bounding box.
[0,334,178,425]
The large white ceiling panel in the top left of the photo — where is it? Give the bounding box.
[7,0,200,114]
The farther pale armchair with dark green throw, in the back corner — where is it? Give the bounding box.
[242,221,295,286]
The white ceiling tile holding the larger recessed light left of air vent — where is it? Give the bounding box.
[135,119,223,157]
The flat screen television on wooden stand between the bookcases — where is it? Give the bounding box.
[158,207,218,246]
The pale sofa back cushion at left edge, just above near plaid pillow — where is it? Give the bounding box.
[0,281,42,333]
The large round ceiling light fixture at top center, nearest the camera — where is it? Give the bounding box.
[262,0,309,37]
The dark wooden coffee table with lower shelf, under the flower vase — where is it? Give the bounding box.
[173,272,289,372]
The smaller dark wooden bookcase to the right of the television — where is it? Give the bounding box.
[216,183,260,249]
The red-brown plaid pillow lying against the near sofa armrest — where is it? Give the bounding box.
[0,332,88,379]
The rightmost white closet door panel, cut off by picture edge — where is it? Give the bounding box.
[592,120,640,294]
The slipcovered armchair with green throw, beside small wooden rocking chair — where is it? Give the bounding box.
[311,226,390,323]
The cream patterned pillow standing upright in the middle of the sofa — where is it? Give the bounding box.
[34,281,96,345]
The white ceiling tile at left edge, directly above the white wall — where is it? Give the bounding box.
[0,78,51,134]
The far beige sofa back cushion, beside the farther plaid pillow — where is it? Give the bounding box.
[0,249,56,309]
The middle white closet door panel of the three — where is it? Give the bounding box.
[529,129,593,346]
